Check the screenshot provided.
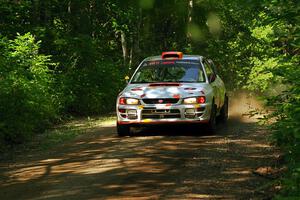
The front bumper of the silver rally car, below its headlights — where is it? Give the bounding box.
[117,103,211,125]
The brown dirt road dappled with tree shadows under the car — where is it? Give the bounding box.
[0,93,276,200]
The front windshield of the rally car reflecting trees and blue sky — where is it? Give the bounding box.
[131,61,205,83]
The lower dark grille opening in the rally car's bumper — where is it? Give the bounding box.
[142,109,181,119]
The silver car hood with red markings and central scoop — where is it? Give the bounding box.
[120,83,208,99]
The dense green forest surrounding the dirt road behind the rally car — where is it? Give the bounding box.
[0,0,300,199]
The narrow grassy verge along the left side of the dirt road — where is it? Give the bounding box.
[0,114,116,160]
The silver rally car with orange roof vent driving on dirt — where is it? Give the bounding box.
[116,52,228,136]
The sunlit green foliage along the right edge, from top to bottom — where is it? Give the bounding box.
[247,1,300,199]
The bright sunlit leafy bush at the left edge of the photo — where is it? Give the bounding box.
[0,33,59,143]
